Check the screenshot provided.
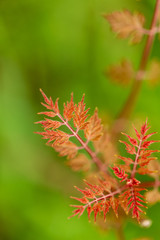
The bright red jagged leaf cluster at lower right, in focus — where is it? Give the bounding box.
[72,121,157,222]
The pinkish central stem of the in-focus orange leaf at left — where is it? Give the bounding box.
[57,113,107,173]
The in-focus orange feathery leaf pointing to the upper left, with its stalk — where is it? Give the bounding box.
[37,90,105,171]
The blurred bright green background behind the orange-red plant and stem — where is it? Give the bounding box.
[0,0,160,240]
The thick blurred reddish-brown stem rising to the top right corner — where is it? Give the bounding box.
[111,0,160,135]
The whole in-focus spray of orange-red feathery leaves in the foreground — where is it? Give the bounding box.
[37,90,158,224]
